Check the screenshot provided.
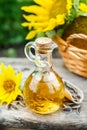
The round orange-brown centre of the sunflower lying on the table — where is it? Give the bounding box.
[4,80,16,92]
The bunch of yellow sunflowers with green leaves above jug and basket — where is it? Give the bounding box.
[21,0,87,40]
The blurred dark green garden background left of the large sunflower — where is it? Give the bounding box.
[0,0,32,57]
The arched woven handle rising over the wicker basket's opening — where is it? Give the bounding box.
[66,33,87,44]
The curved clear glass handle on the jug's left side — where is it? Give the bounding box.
[24,42,36,62]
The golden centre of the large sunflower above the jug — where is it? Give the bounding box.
[50,0,67,18]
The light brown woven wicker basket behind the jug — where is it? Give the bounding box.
[53,34,87,78]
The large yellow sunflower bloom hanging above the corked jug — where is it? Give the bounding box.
[22,0,72,39]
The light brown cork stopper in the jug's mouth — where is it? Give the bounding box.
[35,37,52,48]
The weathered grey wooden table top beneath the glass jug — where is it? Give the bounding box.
[0,58,87,130]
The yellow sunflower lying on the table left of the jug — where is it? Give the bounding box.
[0,63,22,104]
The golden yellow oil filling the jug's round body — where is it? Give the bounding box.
[23,70,65,114]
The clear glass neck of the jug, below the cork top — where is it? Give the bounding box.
[35,47,52,72]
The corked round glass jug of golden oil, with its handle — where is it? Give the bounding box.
[23,37,65,114]
